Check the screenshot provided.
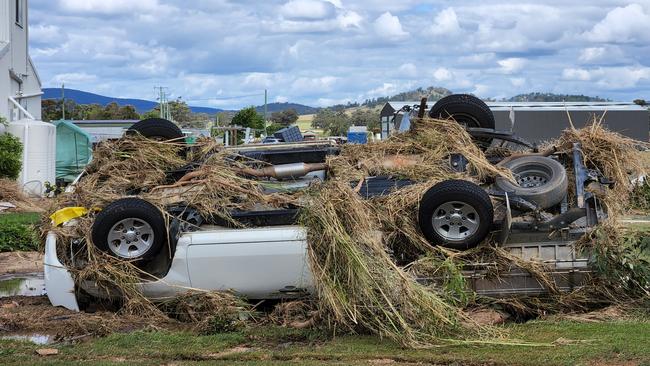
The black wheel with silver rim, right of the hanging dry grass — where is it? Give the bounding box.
[418,180,494,250]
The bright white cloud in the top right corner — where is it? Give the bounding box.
[586,4,650,43]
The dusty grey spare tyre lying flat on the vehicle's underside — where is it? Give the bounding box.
[495,156,569,209]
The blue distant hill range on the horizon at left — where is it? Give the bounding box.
[43,88,223,115]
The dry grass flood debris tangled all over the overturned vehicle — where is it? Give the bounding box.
[43,119,650,346]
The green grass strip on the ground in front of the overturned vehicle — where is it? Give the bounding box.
[0,321,650,365]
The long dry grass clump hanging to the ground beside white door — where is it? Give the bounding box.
[301,181,470,346]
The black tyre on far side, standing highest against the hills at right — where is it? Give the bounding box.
[429,94,495,128]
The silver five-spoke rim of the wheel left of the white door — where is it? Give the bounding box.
[108,218,154,259]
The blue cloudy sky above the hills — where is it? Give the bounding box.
[29,0,650,108]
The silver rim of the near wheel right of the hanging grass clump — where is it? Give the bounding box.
[431,201,481,242]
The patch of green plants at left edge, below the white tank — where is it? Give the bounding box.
[0,213,40,253]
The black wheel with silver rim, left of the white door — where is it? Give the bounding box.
[92,198,167,260]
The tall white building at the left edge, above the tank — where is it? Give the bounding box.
[0,0,42,122]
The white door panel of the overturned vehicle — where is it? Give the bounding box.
[187,226,312,299]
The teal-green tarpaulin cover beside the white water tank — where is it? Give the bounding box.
[54,121,93,182]
